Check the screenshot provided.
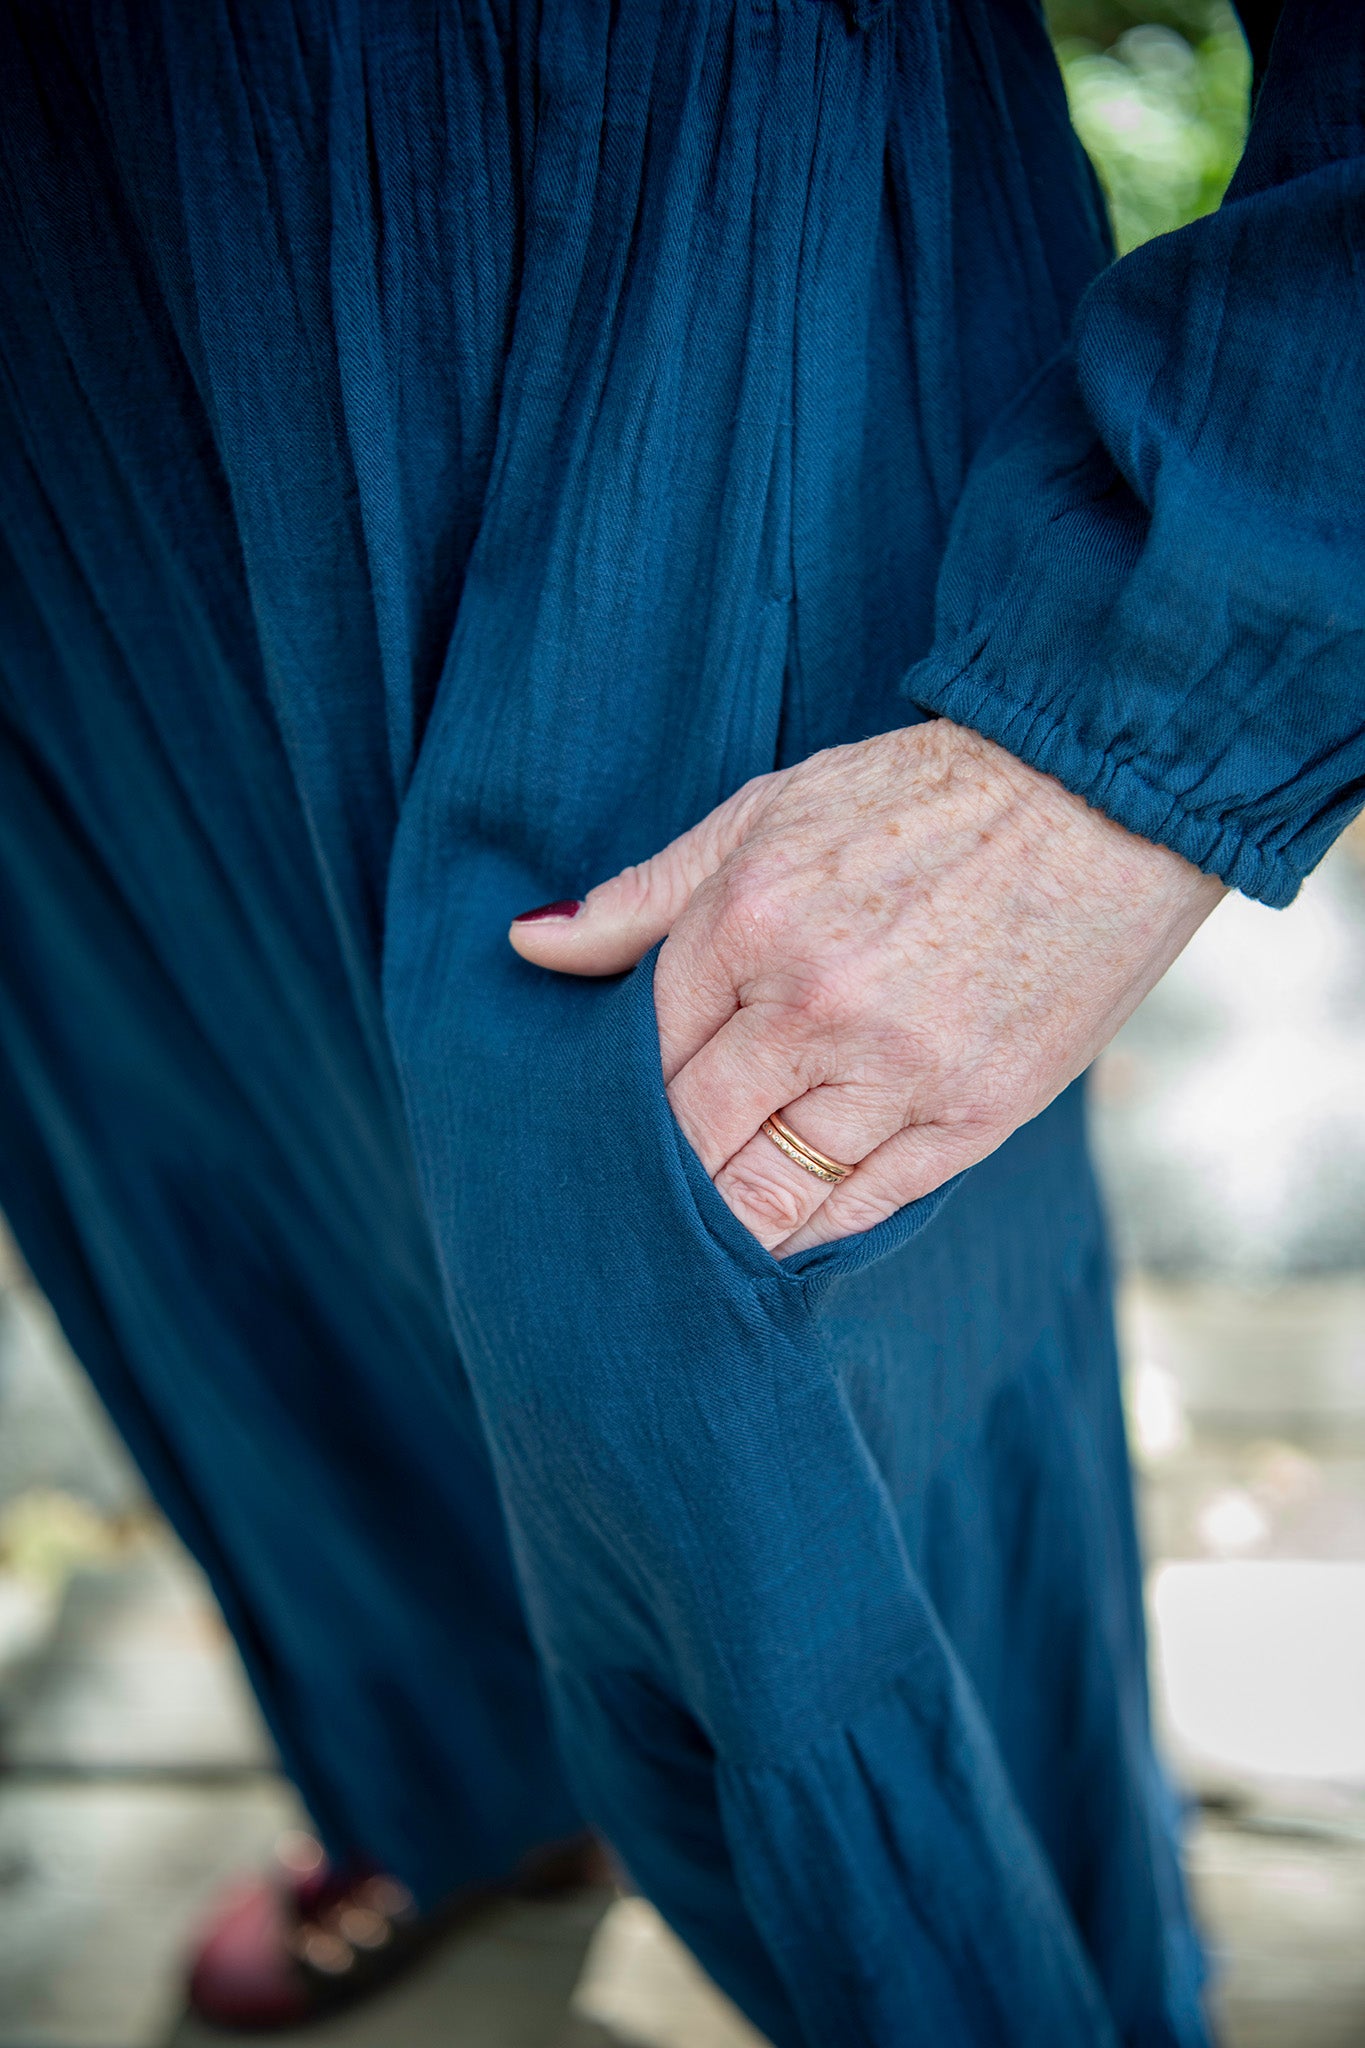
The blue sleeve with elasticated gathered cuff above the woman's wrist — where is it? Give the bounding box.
[907,0,1365,903]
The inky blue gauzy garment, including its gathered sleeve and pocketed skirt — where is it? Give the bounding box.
[0,0,1365,2048]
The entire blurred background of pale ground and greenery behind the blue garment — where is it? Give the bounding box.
[0,0,1365,2048]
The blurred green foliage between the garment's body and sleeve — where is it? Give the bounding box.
[1048,0,1250,252]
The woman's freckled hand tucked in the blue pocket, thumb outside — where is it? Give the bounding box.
[512,719,1224,1255]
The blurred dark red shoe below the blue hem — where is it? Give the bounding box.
[188,1833,612,2034]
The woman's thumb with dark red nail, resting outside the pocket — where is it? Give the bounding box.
[508,774,778,975]
